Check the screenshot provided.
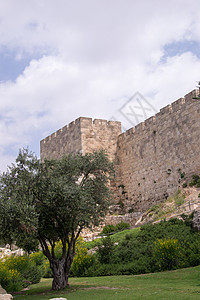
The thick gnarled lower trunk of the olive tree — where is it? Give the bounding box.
[50,257,73,290]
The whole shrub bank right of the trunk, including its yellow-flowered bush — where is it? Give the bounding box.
[85,216,200,276]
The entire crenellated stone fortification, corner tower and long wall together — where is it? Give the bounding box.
[40,91,200,216]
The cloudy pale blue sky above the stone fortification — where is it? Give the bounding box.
[0,0,200,172]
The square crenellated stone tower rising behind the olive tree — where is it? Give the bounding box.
[40,117,121,160]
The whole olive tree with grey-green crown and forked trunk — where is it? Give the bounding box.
[0,149,113,290]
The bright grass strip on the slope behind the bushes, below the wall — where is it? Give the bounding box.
[85,227,140,250]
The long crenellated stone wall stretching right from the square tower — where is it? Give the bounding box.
[116,91,200,212]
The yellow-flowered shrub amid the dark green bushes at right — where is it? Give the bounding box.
[154,238,181,271]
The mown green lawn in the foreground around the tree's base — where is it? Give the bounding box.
[14,266,200,300]
